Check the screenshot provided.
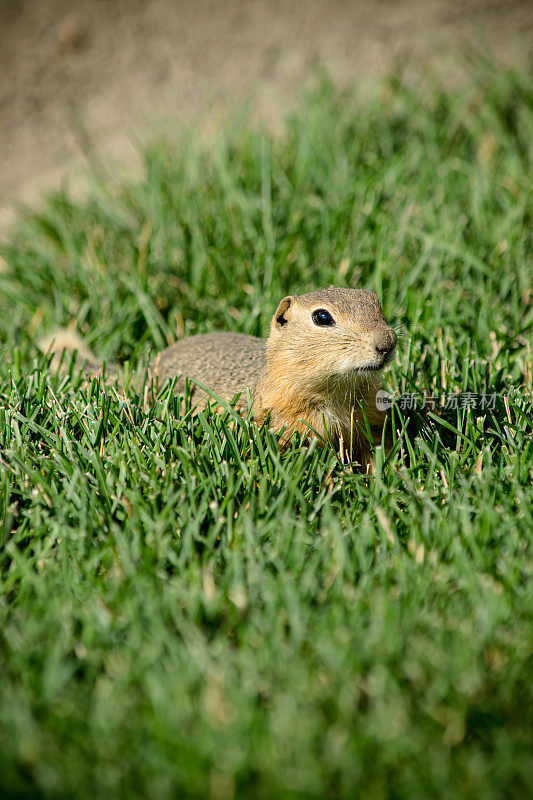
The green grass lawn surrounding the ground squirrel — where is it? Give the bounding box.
[0,67,533,800]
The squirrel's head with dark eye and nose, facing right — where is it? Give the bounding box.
[267,287,397,392]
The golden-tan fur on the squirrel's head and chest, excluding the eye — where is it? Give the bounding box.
[254,288,396,471]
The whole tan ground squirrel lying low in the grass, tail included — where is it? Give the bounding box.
[41,288,397,470]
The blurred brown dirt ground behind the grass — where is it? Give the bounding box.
[0,0,533,235]
